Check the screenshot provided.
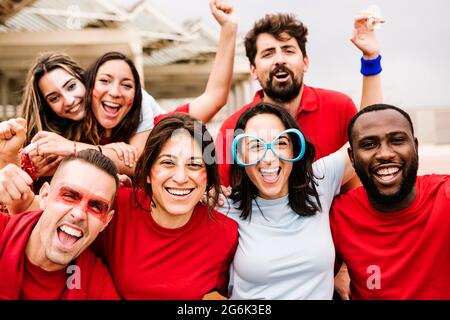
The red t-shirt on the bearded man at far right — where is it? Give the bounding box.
[330,175,450,299]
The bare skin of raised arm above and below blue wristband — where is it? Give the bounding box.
[350,12,384,109]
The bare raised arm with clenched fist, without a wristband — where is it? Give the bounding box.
[189,0,237,123]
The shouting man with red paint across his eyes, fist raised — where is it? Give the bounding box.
[0,150,120,300]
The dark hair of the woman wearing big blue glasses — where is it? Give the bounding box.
[230,103,322,219]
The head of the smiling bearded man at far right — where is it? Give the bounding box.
[349,109,418,209]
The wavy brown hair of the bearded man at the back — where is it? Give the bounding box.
[245,13,308,65]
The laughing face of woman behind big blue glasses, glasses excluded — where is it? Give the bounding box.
[244,113,294,199]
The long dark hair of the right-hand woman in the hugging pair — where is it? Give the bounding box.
[81,52,142,144]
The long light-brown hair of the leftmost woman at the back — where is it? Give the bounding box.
[20,52,84,144]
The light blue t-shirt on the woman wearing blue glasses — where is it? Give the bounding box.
[219,152,345,300]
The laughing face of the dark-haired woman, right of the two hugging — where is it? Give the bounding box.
[92,60,136,136]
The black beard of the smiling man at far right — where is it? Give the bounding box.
[355,155,419,205]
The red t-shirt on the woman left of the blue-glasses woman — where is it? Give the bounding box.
[95,187,238,300]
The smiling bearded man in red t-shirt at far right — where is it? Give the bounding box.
[330,104,450,300]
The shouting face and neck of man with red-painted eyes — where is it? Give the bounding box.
[31,160,116,271]
